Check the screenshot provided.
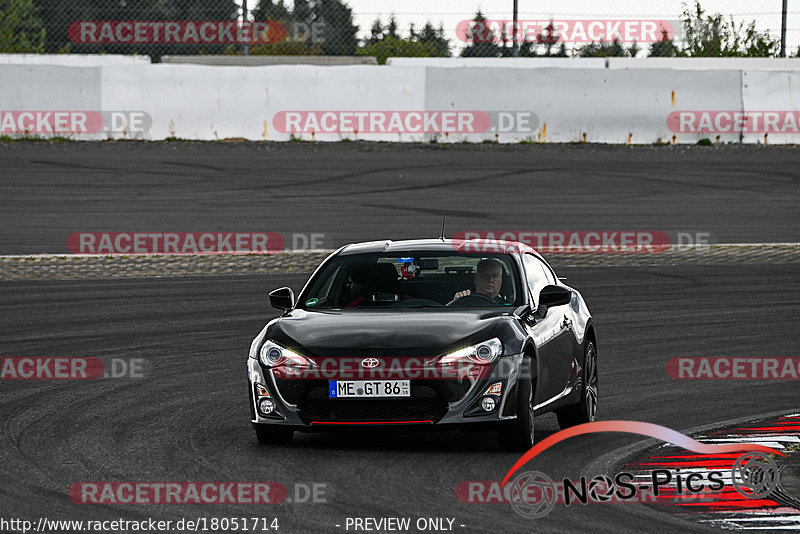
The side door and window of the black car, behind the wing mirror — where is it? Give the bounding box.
[522,253,574,407]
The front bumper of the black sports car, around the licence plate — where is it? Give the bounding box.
[247,354,522,431]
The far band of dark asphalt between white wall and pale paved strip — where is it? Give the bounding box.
[0,142,800,254]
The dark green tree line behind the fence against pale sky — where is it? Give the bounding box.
[0,0,788,59]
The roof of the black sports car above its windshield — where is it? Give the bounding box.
[339,239,539,256]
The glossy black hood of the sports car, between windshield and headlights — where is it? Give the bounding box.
[267,309,509,357]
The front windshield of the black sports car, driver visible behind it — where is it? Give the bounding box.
[299,251,522,310]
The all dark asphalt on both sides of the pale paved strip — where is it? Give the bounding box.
[0,144,800,532]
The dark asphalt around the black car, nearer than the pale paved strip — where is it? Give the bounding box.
[0,265,800,532]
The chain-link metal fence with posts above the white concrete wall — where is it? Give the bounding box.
[0,0,800,63]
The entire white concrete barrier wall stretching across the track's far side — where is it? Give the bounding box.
[0,64,800,144]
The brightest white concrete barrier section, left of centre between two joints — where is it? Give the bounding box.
[103,65,425,141]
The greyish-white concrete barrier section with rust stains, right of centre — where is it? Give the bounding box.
[425,68,741,144]
